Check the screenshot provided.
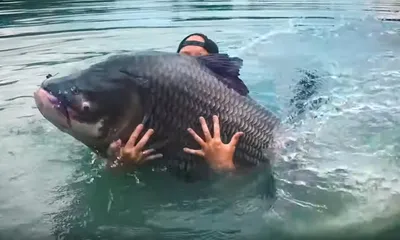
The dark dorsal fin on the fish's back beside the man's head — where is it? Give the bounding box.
[196,54,249,96]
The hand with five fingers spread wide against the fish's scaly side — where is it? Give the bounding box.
[183,115,244,171]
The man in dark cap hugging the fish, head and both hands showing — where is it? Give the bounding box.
[109,33,243,171]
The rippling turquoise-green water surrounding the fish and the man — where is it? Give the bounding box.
[0,0,400,239]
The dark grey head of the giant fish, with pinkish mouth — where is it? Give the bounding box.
[34,66,144,155]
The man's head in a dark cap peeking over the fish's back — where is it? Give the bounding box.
[177,33,219,56]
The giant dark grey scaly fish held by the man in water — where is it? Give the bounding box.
[34,51,280,181]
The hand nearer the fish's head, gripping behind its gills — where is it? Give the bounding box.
[107,124,162,167]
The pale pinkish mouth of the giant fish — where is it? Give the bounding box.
[34,88,71,128]
